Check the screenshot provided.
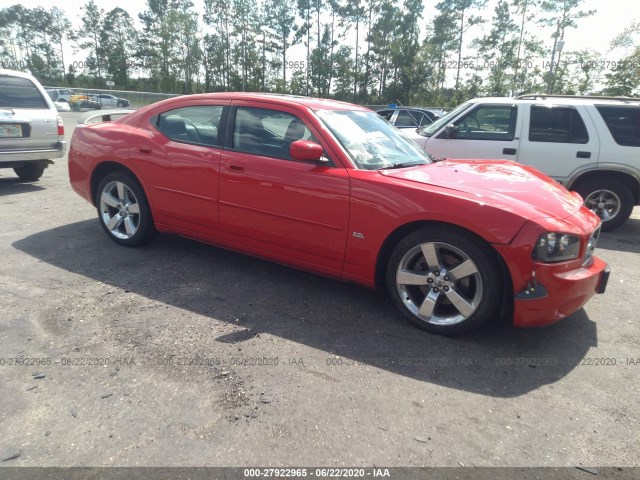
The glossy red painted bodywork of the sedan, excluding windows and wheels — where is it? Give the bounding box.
[69,93,606,326]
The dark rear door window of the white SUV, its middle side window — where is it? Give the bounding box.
[529,105,589,143]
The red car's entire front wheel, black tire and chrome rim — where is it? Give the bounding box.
[386,225,502,335]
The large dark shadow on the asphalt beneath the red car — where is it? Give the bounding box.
[13,220,597,397]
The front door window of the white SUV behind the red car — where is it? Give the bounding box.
[455,105,518,141]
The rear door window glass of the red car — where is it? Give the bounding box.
[158,105,223,147]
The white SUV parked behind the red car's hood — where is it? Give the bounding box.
[405,95,640,230]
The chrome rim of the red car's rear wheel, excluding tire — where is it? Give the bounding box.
[100,181,140,240]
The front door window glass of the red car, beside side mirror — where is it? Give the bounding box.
[233,107,316,159]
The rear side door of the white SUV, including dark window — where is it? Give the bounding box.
[518,104,599,181]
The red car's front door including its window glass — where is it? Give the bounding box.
[220,101,349,273]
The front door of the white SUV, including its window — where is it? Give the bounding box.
[425,103,521,160]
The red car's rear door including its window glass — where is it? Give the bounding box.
[131,104,228,237]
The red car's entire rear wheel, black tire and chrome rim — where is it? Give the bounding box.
[95,172,158,247]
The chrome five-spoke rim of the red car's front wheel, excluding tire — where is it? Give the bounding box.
[396,242,482,326]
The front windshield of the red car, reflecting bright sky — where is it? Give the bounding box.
[316,110,431,170]
